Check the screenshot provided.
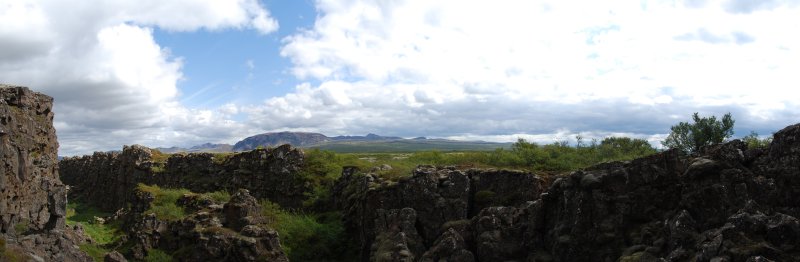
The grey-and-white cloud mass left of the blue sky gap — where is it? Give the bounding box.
[0,0,278,155]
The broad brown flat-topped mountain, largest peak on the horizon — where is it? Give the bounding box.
[233,132,329,151]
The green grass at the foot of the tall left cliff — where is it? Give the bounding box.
[67,201,124,261]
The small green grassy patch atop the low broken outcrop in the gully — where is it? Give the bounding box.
[137,183,191,221]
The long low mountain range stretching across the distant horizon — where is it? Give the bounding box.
[157,132,511,153]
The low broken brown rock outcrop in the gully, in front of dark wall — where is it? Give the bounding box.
[123,187,289,261]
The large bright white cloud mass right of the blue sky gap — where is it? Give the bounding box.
[264,0,800,145]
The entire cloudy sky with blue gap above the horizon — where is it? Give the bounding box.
[0,0,800,156]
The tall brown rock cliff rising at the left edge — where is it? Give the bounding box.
[0,85,91,261]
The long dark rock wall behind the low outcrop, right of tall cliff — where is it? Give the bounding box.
[59,145,308,211]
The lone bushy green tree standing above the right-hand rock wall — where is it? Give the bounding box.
[661,112,734,153]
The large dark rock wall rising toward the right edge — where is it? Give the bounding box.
[332,124,800,261]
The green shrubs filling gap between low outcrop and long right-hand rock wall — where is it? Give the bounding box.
[260,200,358,261]
